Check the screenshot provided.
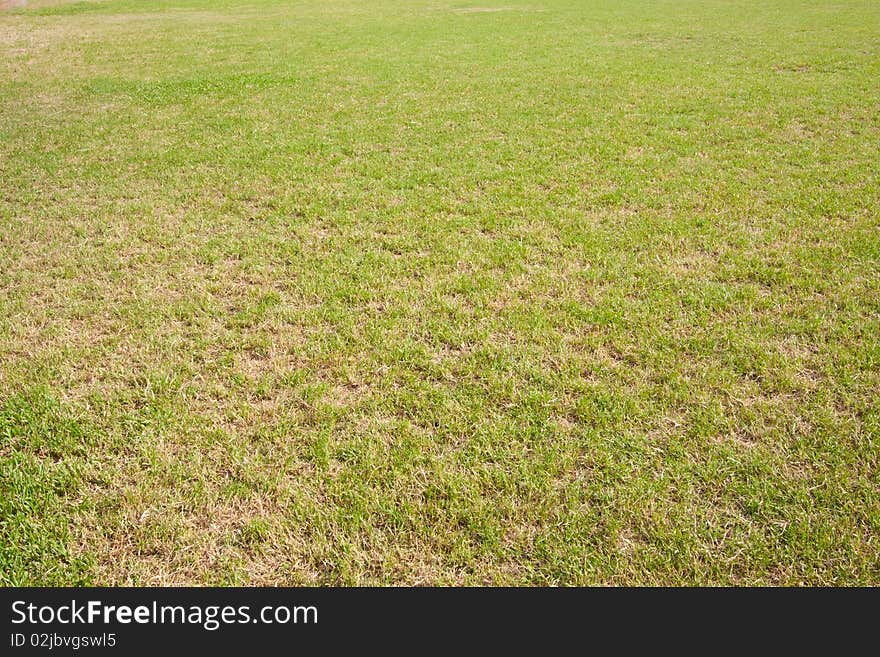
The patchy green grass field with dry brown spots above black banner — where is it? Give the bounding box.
[0,0,880,585]
